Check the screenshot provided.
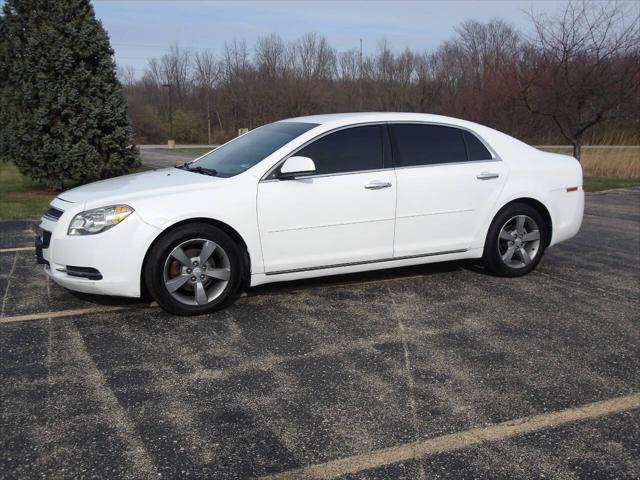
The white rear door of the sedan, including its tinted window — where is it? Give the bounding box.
[389,123,507,257]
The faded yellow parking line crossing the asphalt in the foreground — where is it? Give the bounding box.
[262,394,640,480]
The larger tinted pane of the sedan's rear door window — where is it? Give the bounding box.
[389,124,467,167]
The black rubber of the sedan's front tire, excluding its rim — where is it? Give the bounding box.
[144,223,243,316]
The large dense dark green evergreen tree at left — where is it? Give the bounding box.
[0,0,138,188]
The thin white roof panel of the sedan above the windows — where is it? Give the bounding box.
[281,112,478,127]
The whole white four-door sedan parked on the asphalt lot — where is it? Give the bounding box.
[36,113,584,315]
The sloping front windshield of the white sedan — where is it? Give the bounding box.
[188,122,318,177]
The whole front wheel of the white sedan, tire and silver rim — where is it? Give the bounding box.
[144,223,243,316]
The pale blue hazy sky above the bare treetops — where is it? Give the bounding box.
[86,0,584,75]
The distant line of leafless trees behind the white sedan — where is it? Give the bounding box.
[119,2,640,159]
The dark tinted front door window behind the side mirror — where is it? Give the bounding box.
[296,125,382,175]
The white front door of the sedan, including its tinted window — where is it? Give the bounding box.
[257,125,396,274]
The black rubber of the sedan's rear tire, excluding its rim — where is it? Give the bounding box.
[482,203,548,277]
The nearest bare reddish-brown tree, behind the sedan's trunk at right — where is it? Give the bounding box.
[521,1,640,160]
